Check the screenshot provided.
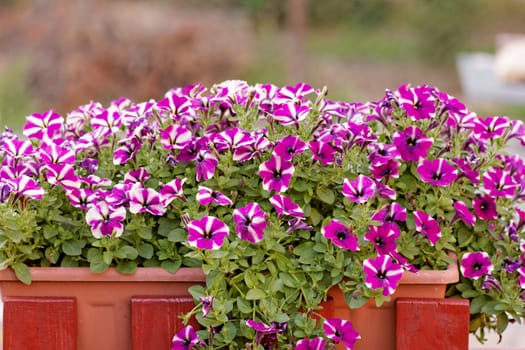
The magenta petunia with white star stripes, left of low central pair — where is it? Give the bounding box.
[187,216,230,250]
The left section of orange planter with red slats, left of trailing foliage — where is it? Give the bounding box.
[0,267,205,350]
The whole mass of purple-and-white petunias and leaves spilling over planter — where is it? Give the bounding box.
[0,81,525,349]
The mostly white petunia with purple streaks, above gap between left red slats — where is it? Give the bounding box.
[86,201,126,238]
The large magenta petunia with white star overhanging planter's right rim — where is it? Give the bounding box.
[363,255,403,296]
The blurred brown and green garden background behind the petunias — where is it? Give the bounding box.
[0,0,525,130]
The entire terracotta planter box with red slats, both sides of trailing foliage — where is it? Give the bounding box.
[0,264,469,350]
